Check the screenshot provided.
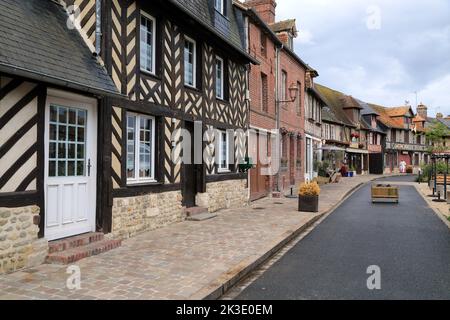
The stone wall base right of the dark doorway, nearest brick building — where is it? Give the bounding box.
[196,180,249,212]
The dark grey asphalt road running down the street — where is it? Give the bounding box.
[237,177,450,300]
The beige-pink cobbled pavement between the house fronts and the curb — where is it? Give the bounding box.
[0,176,384,300]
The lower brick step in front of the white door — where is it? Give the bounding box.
[46,240,122,265]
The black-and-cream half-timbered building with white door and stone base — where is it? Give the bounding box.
[0,0,255,272]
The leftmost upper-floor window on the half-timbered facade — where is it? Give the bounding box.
[140,12,156,73]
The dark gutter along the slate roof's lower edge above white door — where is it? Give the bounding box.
[0,63,123,98]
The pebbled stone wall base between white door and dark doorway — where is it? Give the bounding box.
[112,191,186,239]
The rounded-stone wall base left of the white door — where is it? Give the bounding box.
[0,206,48,274]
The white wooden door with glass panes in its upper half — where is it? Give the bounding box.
[45,91,97,240]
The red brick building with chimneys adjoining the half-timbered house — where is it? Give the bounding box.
[244,0,311,198]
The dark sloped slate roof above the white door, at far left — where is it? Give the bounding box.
[0,0,119,95]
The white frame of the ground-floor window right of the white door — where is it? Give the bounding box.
[126,112,157,185]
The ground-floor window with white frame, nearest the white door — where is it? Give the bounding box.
[127,114,155,183]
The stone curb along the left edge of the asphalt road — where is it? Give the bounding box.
[189,178,370,300]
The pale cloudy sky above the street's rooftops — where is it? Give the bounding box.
[277,0,450,116]
